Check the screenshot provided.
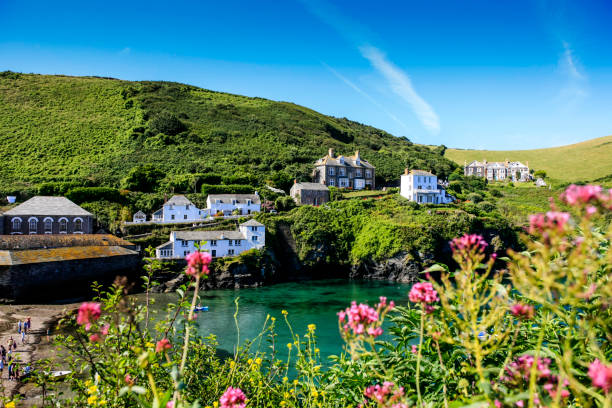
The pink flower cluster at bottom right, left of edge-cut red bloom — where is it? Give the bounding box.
[502,355,569,400]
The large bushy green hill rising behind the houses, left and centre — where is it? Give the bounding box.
[0,72,455,193]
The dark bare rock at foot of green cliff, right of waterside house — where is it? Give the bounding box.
[349,252,424,283]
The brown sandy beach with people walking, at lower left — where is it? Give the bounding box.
[0,304,79,407]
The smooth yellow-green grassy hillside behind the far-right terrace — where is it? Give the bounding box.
[445,136,612,182]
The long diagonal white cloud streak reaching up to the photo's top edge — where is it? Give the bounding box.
[301,0,440,134]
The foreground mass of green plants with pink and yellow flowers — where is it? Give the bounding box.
[23,186,612,408]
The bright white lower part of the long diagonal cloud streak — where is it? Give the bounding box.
[359,45,440,134]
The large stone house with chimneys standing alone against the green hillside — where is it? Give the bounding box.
[313,149,376,190]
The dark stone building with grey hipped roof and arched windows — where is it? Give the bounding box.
[0,196,94,235]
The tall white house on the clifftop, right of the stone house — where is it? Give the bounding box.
[400,169,455,204]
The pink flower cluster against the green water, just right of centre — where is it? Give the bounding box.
[338,297,395,337]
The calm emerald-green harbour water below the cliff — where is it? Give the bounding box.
[146,280,410,357]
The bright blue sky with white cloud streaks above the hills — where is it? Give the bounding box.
[0,0,612,150]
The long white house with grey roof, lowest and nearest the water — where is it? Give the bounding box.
[155,220,266,259]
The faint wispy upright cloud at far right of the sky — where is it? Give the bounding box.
[558,41,588,109]
